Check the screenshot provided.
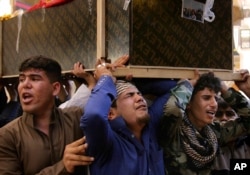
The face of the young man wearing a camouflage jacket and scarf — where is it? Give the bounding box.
[188,88,217,130]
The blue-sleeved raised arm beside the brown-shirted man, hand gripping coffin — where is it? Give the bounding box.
[80,62,116,157]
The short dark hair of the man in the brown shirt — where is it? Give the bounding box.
[19,55,62,82]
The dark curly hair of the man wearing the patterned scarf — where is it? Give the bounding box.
[191,72,221,100]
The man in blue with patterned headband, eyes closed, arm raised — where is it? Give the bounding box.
[81,62,176,175]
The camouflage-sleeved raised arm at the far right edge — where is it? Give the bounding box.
[213,72,250,145]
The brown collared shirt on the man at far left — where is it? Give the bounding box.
[0,107,86,175]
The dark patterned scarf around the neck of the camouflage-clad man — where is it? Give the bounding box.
[181,115,218,170]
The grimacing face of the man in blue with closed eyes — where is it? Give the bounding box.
[116,87,149,127]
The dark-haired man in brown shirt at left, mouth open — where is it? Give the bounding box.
[0,56,94,175]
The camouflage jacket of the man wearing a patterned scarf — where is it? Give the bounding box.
[160,80,250,175]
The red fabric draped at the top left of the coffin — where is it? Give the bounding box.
[27,0,72,12]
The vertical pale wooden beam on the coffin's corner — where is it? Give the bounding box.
[96,0,106,58]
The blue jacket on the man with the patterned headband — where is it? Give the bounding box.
[80,76,176,175]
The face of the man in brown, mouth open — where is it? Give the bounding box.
[18,68,60,115]
